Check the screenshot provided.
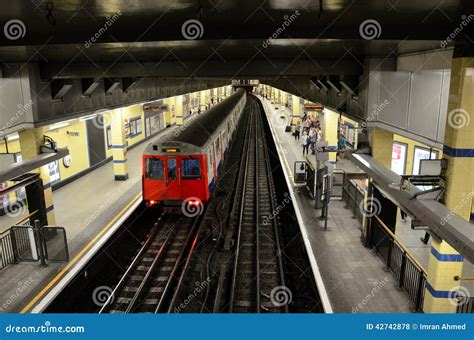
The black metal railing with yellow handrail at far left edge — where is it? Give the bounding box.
[0,211,38,270]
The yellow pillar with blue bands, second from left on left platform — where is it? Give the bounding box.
[110,109,130,181]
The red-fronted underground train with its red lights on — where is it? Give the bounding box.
[142,88,247,207]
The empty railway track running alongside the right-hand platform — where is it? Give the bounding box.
[229,98,288,313]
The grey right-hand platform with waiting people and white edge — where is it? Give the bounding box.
[259,97,412,313]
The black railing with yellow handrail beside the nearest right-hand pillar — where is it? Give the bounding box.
[369,215,427,312]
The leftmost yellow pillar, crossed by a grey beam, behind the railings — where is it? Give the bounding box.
[18,128,56,225]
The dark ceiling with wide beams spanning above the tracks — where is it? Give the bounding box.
[0,0,466,79]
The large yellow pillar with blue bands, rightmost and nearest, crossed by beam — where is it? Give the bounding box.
[423,57,474,313]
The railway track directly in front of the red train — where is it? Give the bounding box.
[99,214,200,313]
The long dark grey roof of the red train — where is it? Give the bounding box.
[145,89,245,154]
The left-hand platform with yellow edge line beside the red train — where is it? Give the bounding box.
[0,126,181,313]
